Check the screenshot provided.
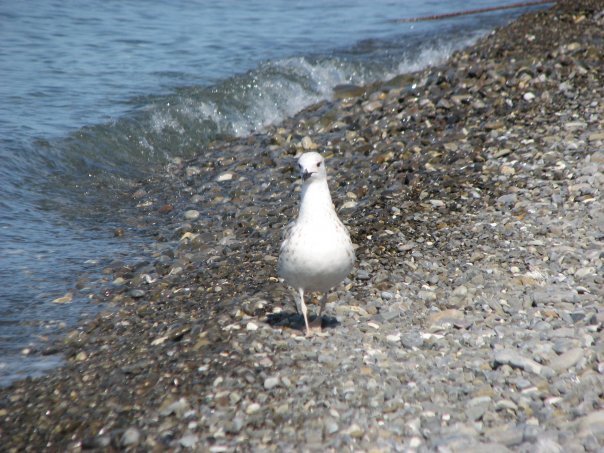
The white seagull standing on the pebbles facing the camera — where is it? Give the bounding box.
[277,152,355,336]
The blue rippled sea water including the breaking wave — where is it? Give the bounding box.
[0,0,548,385]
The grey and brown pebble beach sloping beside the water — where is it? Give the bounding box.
[0,0,604,453]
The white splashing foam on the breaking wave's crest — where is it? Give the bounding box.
[146,35,490,152]
